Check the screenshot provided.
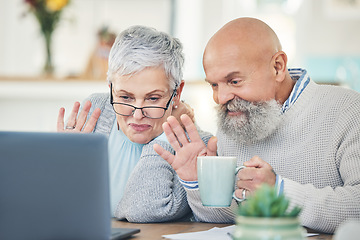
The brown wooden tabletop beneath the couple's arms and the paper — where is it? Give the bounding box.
[112,220,332,240]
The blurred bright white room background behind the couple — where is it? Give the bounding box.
[0,0,360,134]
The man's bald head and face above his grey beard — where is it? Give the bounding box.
[203,18,294,104]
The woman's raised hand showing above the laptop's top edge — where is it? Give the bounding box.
[57,101,101,133]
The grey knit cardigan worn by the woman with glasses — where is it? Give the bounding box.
[86,93,211,222]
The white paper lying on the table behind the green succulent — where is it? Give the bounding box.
[163,225,319,240]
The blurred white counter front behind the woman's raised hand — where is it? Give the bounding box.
[0,79,108,132]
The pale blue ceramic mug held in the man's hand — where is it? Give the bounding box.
[197,156,245,207]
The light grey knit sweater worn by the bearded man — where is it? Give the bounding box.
[186,81,360,233]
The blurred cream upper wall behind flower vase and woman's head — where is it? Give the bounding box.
[0,0,171,77]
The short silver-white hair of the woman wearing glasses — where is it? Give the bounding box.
[107,26,184,89]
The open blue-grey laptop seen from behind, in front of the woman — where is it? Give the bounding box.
[0,132,140,240]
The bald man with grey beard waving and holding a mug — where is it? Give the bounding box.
[154,18,360,233]
